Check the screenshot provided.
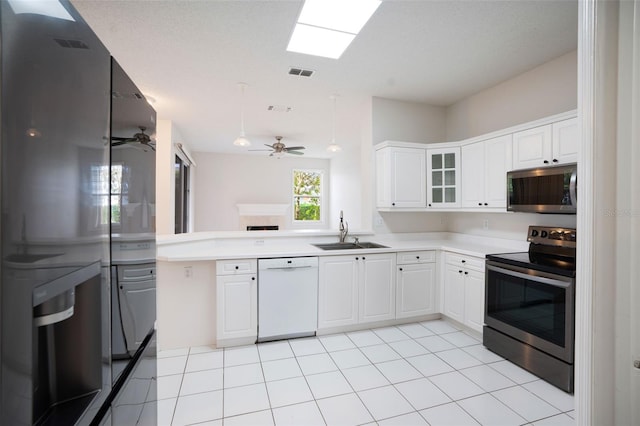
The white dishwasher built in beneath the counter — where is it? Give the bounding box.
[258,257,318,342]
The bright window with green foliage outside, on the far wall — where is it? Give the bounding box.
[293,170,322,222]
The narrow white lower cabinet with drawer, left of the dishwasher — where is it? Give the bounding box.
[216,259,258,346]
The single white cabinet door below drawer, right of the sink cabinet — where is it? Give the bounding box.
[396,263,436,318]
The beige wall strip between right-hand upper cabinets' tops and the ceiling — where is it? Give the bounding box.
[446,51,578,141]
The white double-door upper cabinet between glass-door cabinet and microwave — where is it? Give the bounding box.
[461,135,513,208]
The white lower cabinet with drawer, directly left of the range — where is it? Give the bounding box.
[443,253,485,332]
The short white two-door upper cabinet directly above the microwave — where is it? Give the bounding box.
[513,118,578,169]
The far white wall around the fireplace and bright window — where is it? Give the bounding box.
[193,152,332,231]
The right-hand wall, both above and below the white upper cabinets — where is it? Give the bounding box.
[446,51,578,240]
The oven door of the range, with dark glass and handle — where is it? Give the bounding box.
[485,261,575,364]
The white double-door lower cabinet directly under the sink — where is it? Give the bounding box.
[318,253,395,329]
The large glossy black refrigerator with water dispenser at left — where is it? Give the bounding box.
[0,0,156,425]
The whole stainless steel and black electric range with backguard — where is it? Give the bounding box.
[483,226,576,392]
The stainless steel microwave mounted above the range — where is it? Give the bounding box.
[507,163,578,214]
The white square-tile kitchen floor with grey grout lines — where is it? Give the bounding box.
[158,320,575,426]
